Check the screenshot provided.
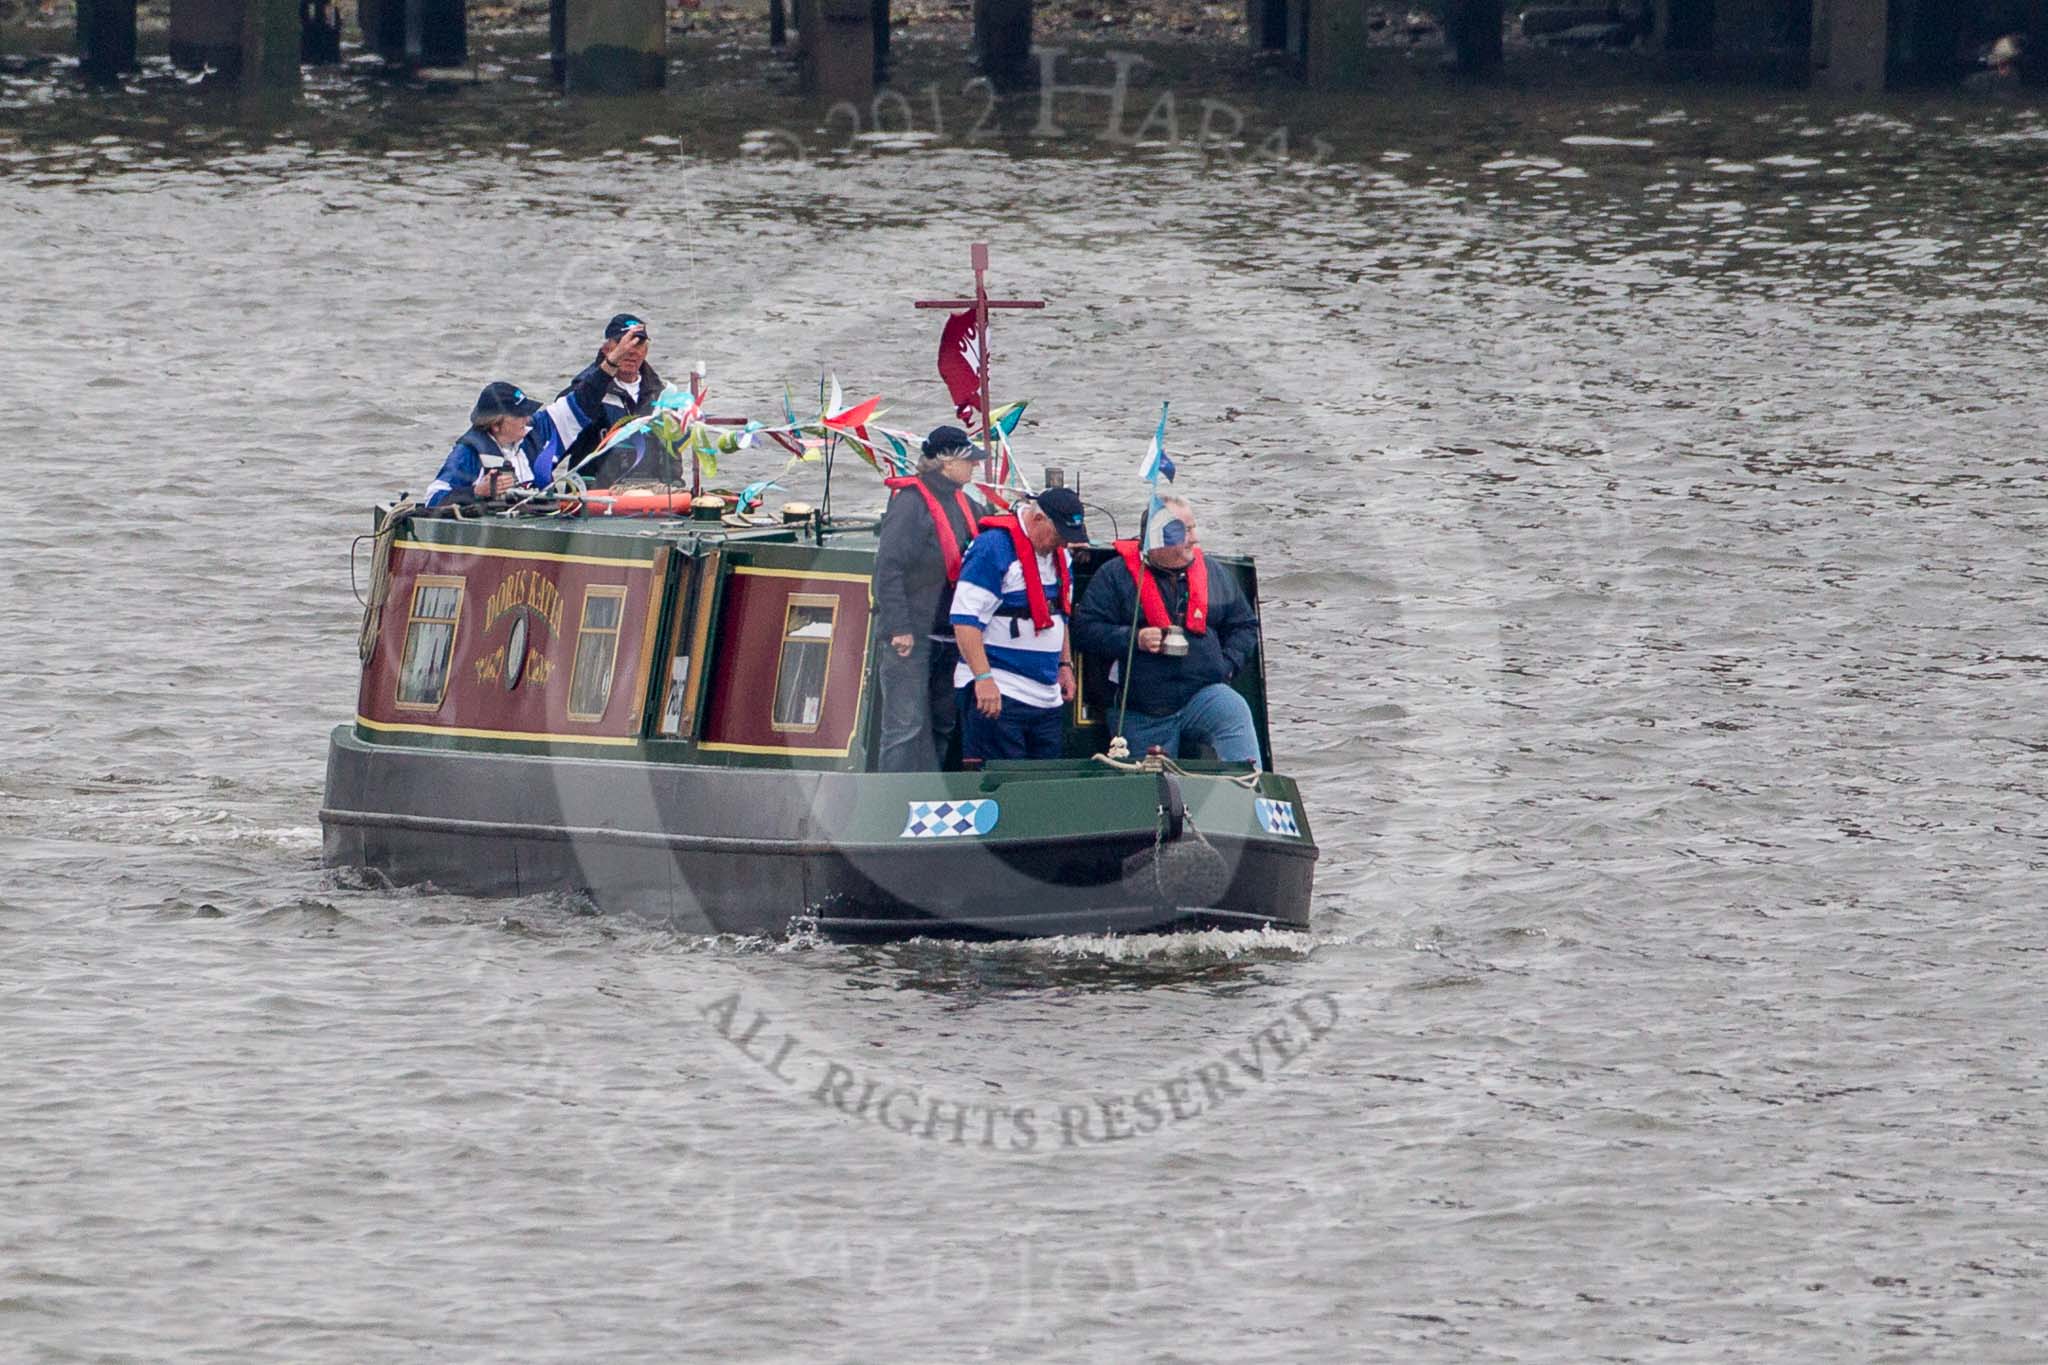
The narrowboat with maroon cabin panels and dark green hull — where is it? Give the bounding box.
[319,505,1317,939]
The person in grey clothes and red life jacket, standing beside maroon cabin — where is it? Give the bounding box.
[874,426,983,772]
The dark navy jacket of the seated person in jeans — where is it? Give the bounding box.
[1073,559,1260,716]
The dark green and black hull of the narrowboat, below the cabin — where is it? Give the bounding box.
[319,726,1317,939]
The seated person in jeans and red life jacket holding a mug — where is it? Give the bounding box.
[1073,497,1260,763]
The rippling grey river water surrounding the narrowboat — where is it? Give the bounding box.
[0,31,2048,1363]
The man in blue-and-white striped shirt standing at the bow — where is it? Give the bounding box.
[952,487,1087,765]
